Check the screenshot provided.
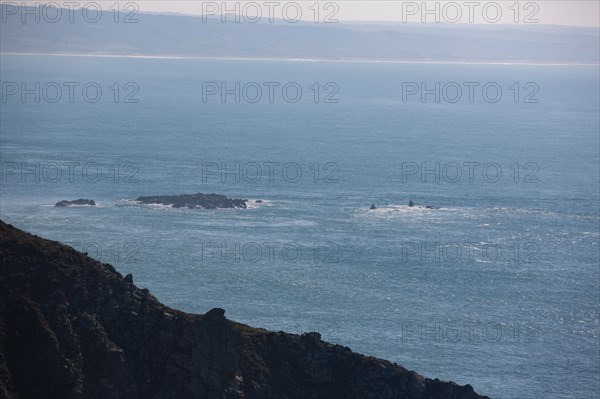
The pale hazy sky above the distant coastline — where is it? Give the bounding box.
[17,0,600,27]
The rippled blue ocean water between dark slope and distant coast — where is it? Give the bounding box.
[0,55,600,399]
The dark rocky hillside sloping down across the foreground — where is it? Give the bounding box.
[0,221,485,399]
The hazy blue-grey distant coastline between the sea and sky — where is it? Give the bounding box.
[0,3,600,65]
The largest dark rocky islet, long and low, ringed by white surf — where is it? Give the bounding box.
[136,193,247,209]
